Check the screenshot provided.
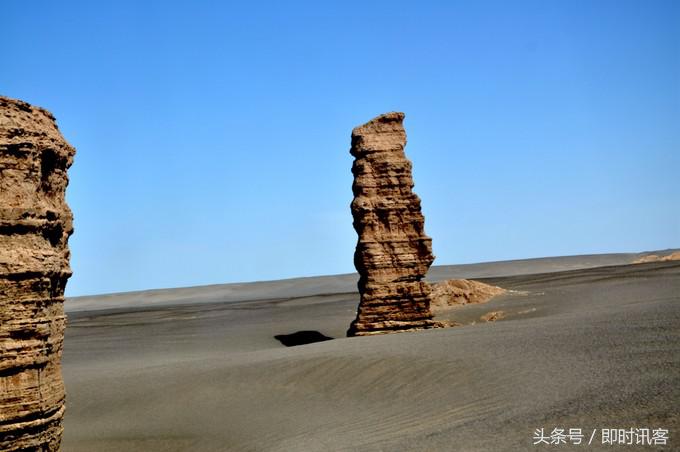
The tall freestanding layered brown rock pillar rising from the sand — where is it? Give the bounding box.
[347,112,435,336]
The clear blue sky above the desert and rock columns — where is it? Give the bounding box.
[0,0,680,295]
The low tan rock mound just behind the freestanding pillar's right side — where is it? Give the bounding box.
[431,279,505,312]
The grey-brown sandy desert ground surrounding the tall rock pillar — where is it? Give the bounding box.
[63,250,680,452]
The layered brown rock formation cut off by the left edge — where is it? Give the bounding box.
[0,97,75,451]
